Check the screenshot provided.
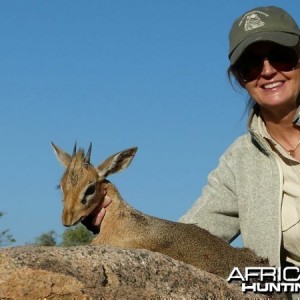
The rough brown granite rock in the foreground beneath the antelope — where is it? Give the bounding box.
[0,245,280,300]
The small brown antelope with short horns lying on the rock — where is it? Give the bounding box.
[52,143,267,278]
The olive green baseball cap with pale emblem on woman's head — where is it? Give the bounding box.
[229,6,300,65]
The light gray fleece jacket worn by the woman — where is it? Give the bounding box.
[179,109,283,266]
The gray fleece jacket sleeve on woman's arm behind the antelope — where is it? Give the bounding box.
[179,151,240,242]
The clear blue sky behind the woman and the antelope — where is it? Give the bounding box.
[0,0,300,245]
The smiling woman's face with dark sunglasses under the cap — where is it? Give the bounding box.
[239,42,300,110]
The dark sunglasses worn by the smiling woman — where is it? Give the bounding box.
[233,45,299,82]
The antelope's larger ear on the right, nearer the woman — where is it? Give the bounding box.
[96,147,138,177]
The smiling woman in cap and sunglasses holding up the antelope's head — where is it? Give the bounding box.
[84,3,300,290]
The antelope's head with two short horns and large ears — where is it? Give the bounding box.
[51,143,137,226]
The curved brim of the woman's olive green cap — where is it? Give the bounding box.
[229,31,299,65]
